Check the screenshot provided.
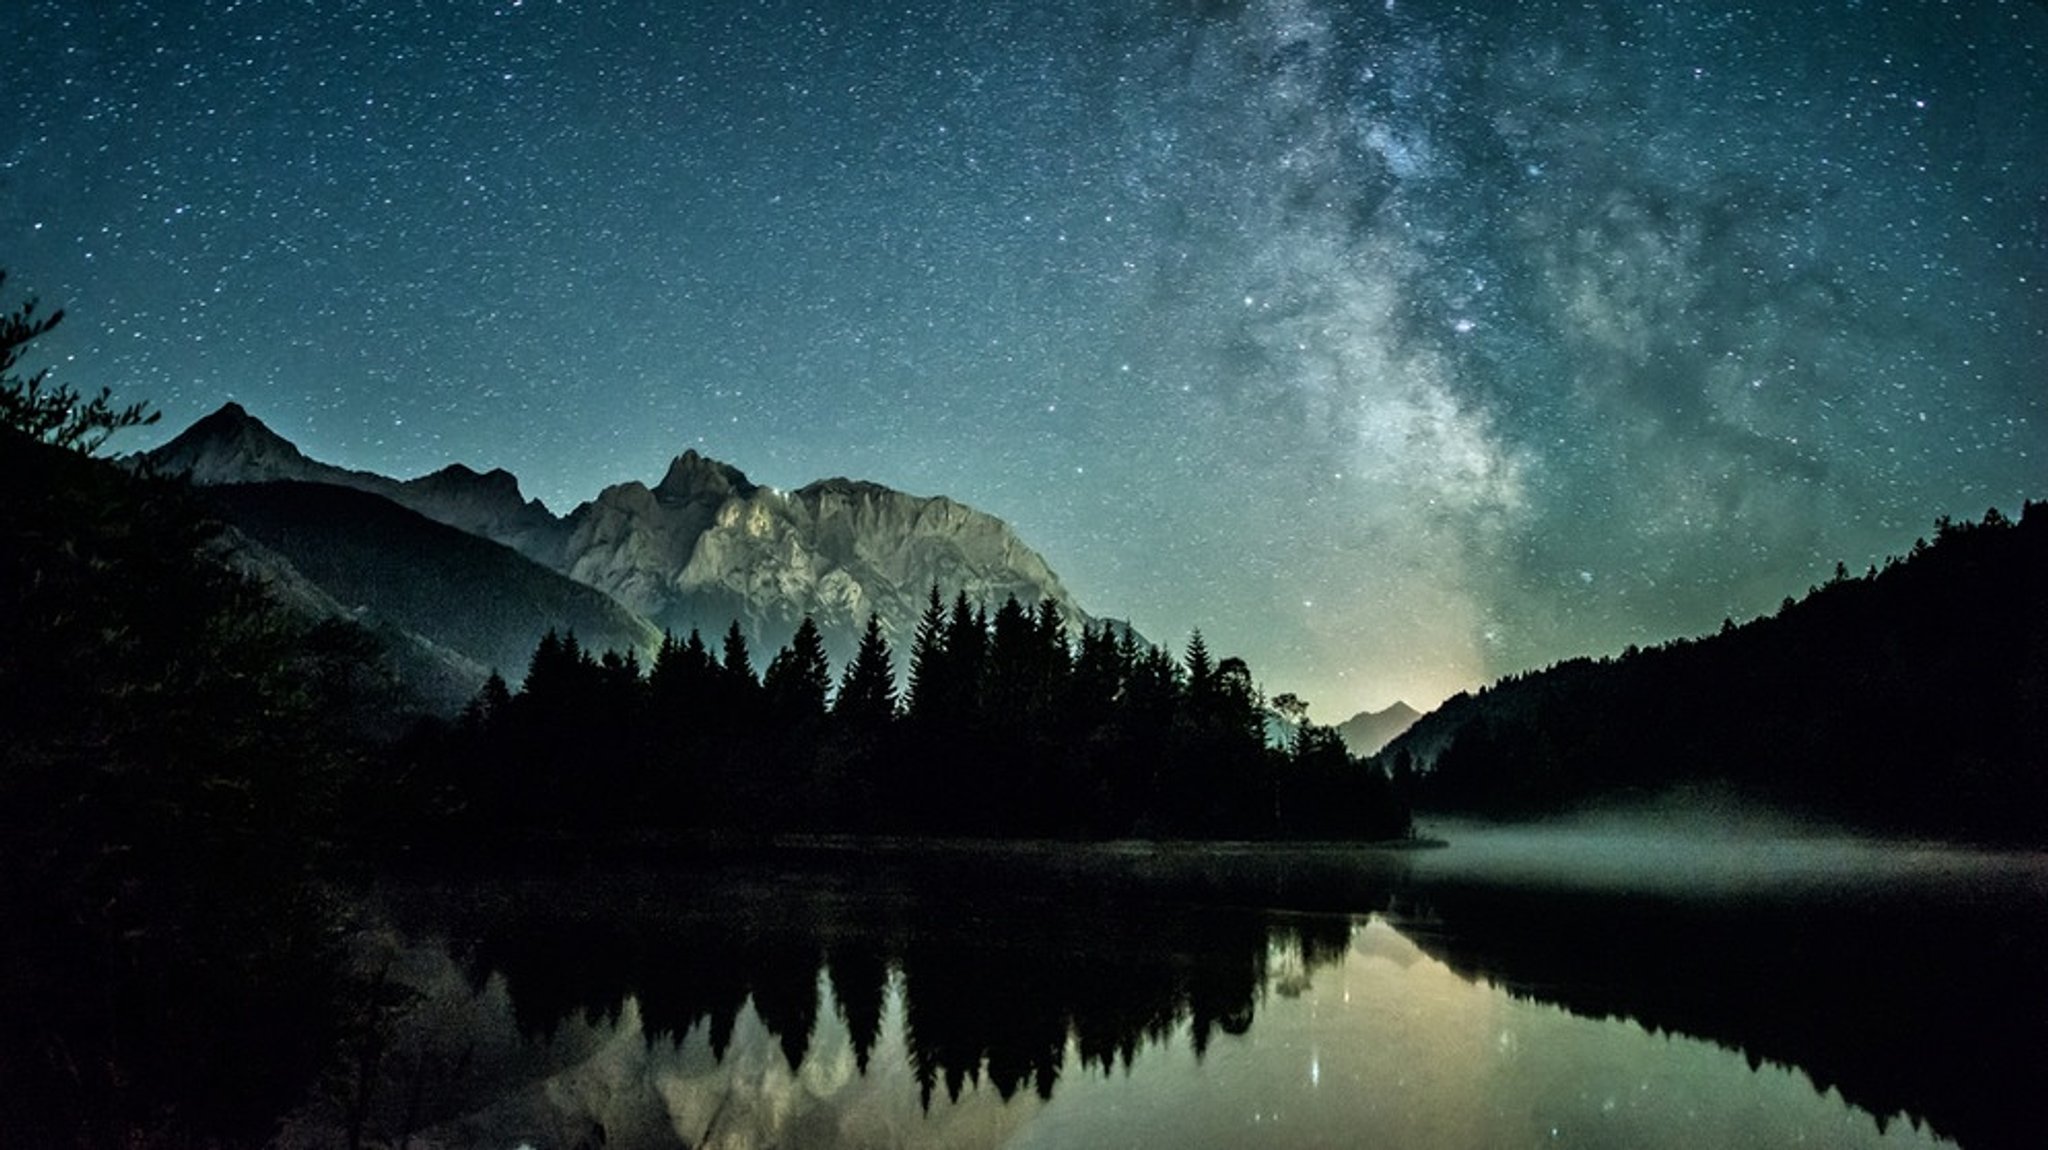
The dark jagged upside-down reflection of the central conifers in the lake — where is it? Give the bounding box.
[399,851,1350,1107]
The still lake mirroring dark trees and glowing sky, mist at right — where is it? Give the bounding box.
[285,827,2048,1148]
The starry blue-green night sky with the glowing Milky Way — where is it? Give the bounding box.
[0,0,2048,722]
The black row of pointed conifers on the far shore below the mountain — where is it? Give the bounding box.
[406,587,1409,839]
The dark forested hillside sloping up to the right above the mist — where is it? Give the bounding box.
[1378,501,2048,841]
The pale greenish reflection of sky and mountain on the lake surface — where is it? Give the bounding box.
[301,917,1939,1148]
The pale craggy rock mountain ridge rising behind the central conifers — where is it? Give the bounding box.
[145,403,1094,659]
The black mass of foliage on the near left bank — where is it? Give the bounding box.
[0,428,367,1146]
